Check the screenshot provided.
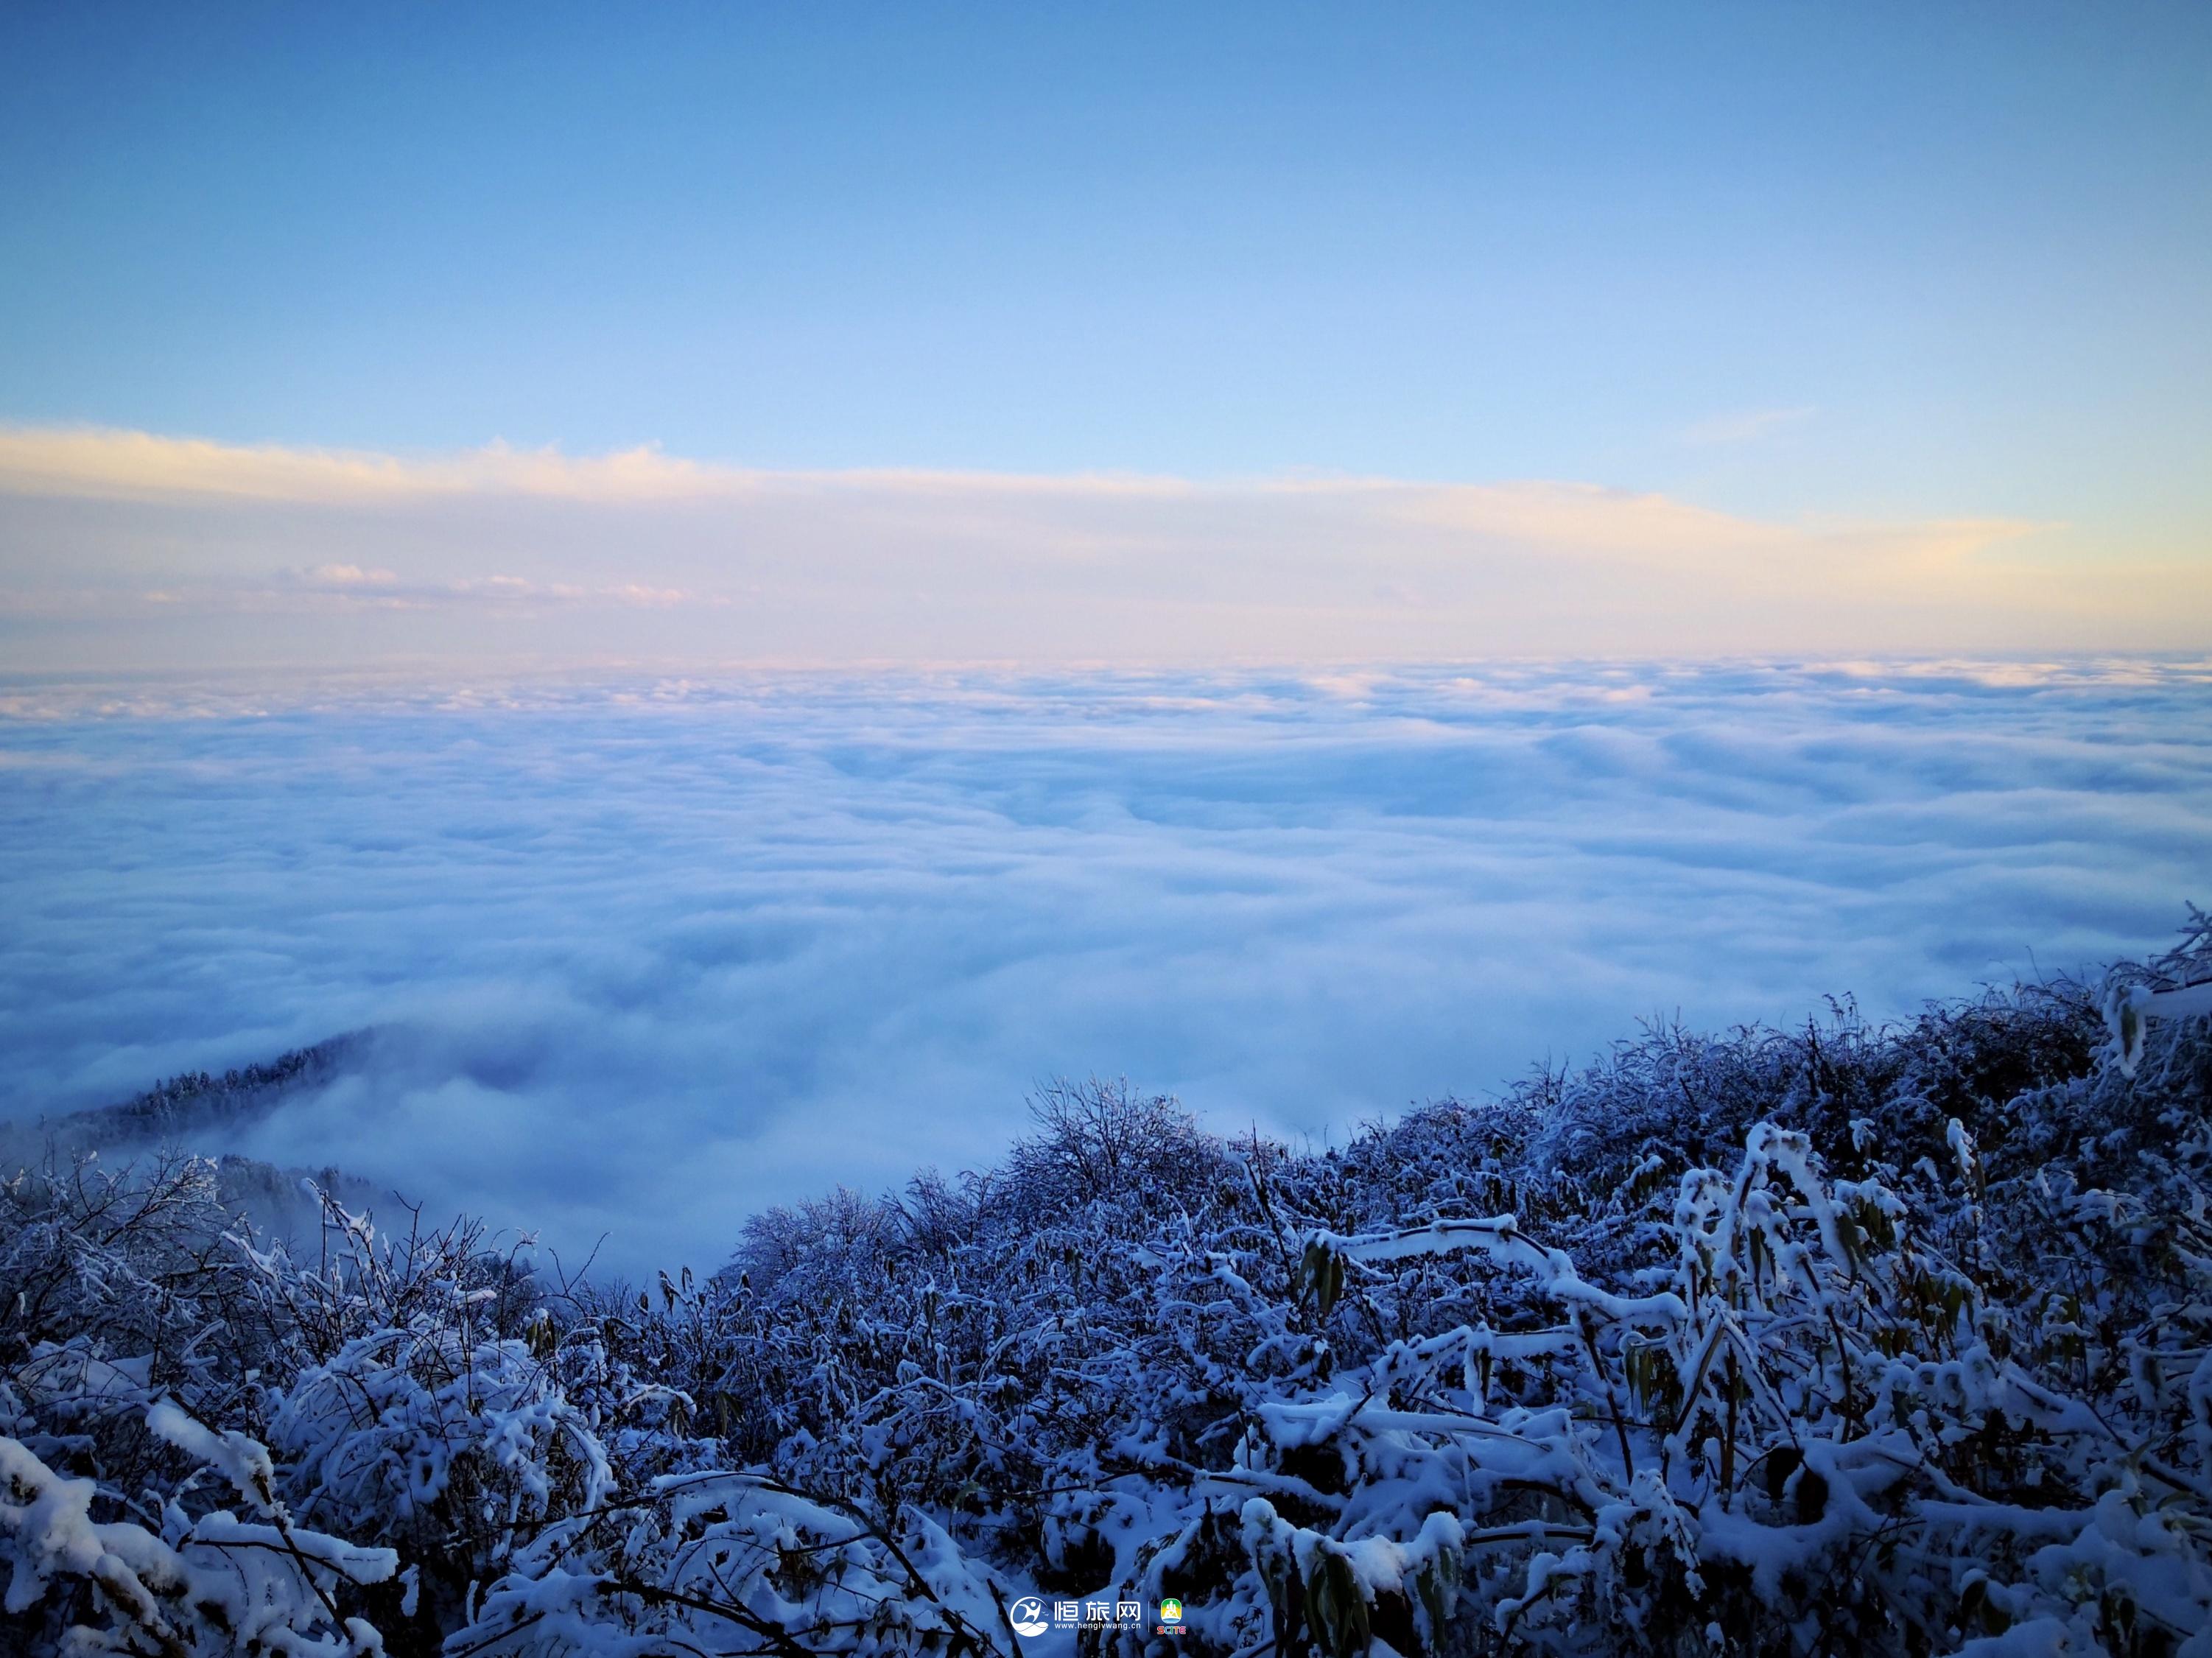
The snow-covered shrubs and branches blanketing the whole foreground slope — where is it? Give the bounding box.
[0,913,2212,1658]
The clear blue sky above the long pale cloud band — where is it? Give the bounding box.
[0,4,2212,654]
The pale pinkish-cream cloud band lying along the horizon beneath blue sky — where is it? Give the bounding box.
[0,424,2212,670]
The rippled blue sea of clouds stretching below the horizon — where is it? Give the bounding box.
[0,661,2212,1271]
